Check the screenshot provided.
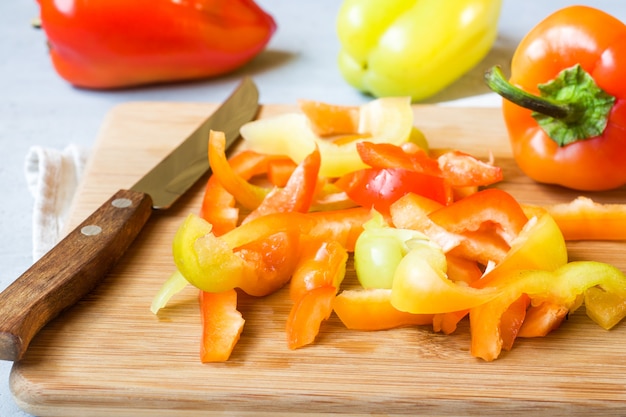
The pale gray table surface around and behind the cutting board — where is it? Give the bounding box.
[0,0,626,417]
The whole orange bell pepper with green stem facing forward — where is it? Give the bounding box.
[486,6,626,191]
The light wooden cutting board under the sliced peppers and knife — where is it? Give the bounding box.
[10,102,626,417]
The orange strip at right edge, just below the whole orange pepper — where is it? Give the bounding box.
[532,197,626,240]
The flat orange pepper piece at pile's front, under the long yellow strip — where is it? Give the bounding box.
[333,288,433,330]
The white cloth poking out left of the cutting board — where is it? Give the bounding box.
[24,145,88,261]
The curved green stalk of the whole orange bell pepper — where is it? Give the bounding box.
[485,66,576,120]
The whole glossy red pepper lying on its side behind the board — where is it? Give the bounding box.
[38,0,276,89]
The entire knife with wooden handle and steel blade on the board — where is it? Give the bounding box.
[0,78,259,361]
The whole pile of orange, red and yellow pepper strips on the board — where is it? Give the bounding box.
[152,99,626,362]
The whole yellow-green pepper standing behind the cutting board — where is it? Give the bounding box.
[337,0,502,101]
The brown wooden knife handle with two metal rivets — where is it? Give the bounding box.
[0,190,152,361]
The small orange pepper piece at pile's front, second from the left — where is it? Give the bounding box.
[287,287,337,349]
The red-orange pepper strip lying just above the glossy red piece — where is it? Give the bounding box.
[356,141,442,176]
